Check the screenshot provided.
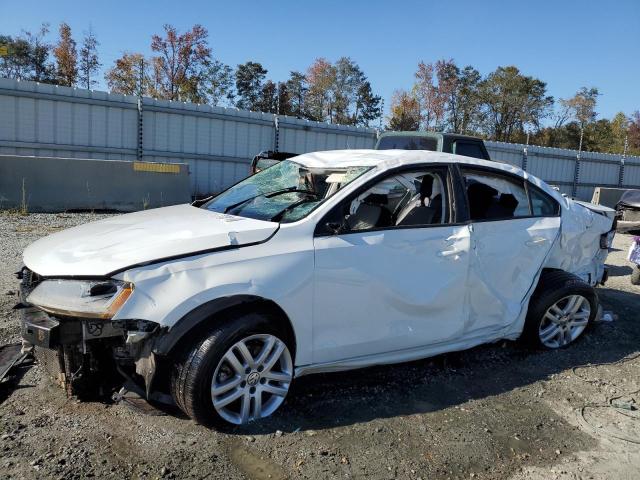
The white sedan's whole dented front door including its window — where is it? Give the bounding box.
[313,169,470,363]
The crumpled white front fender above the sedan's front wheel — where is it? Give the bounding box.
[114,232,314,363]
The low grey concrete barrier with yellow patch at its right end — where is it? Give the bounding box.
[0,155,191,212]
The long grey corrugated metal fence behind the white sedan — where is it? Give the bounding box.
[0,79,640,199]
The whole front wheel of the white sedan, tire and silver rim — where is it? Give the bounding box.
[171,313,293,425]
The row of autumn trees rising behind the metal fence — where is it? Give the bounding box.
[0,19,640,154]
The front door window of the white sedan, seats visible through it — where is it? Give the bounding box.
[345,170,449,232]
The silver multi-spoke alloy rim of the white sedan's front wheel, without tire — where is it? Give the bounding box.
[211,334,293,425]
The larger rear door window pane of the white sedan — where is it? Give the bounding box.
[462,169,531,220]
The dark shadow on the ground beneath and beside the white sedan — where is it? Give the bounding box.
[227,288,640,435]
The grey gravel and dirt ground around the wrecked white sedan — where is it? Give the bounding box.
[0,214,640,480]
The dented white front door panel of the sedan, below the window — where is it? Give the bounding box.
[313,225,469,362]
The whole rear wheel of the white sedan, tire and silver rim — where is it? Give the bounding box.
[522,271,598,349]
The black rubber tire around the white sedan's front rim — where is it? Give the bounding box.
[170,313,293,427]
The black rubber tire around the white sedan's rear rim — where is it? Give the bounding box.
[520,270,598,349]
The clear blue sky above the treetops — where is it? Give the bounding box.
[0,0,640,117]
